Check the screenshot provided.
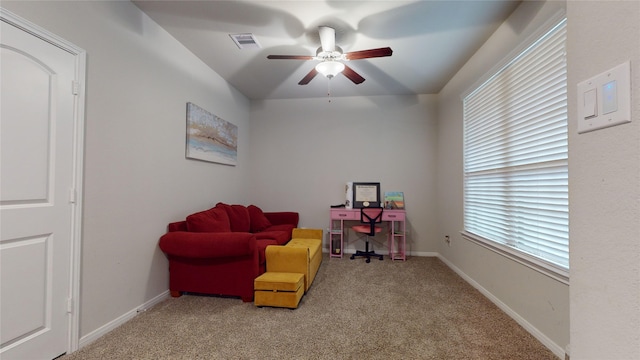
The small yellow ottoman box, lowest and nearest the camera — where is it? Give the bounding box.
[253,272,304,309]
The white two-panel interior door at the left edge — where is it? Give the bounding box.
[0,12,84,359]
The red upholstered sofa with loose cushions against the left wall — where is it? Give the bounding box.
[160,203,299,302]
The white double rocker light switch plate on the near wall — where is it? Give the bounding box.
[577,61,631,133]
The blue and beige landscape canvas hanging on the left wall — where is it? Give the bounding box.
[185,102,238,166]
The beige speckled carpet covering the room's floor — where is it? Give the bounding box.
[61,255,557,360]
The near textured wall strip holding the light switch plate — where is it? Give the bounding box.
[567,1,640,360]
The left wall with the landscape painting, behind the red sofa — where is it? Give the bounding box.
[2,1,250,337]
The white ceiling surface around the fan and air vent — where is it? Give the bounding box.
[133,0,520,99]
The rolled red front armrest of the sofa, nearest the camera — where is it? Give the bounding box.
[160,231,257,259]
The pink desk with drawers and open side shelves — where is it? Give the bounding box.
[329,208,407,261]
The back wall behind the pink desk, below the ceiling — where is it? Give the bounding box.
[250,95,436,254]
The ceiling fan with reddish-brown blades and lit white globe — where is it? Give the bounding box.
[267,26,393,85]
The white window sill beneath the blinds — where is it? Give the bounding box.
[460,231,569,285]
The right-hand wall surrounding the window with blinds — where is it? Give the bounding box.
[436,1,573,356]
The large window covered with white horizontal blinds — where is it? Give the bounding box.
[463,20,569,280]
